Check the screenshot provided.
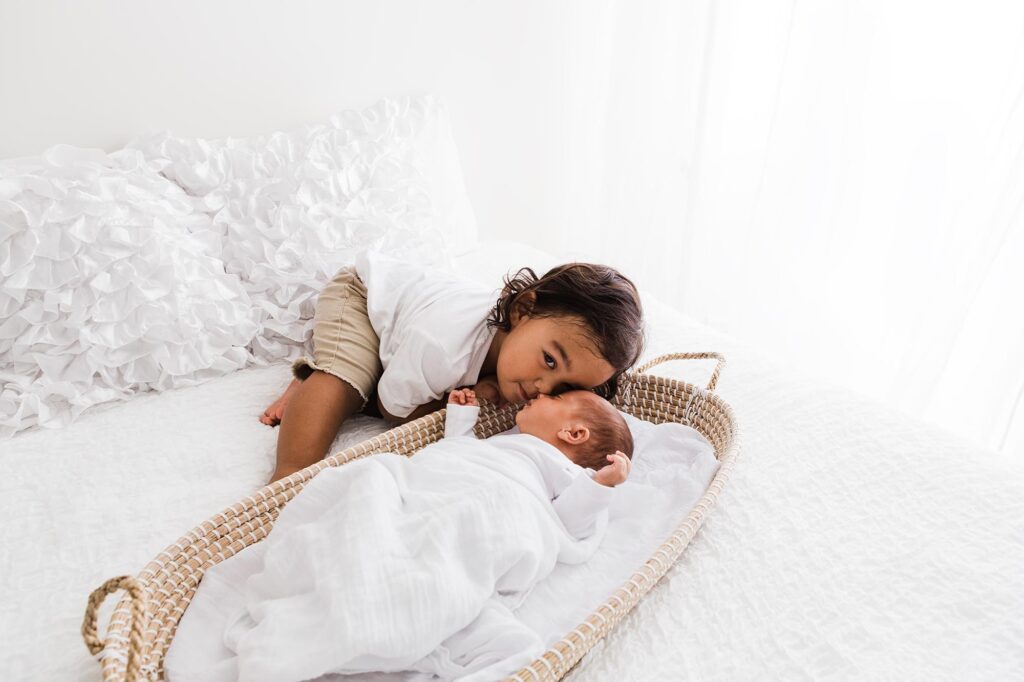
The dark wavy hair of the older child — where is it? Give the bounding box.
[487,263,644,398]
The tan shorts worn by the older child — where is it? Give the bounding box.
[292,267,384,403]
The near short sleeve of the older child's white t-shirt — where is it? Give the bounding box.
[377,336,458,417]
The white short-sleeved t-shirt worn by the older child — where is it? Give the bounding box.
[355,253,500,417]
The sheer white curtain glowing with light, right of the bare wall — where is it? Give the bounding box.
[551,0,1024,463]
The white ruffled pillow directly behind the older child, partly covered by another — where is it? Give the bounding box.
[129,97,476,363]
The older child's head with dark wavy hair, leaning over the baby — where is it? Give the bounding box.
[487,263,643,402]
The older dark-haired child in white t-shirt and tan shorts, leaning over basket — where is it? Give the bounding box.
[261,253,643,481]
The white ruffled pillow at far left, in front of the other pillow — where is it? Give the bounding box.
[0,145,257,437]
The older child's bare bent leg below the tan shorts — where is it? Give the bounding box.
[270,371,362,483]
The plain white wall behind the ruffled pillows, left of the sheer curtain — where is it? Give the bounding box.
[0,0,586,246]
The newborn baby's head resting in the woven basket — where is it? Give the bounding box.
[515,391,633,471]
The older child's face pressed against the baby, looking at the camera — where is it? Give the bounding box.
[496,316,614,402]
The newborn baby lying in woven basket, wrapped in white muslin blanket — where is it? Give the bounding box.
[164,389,633,682]
